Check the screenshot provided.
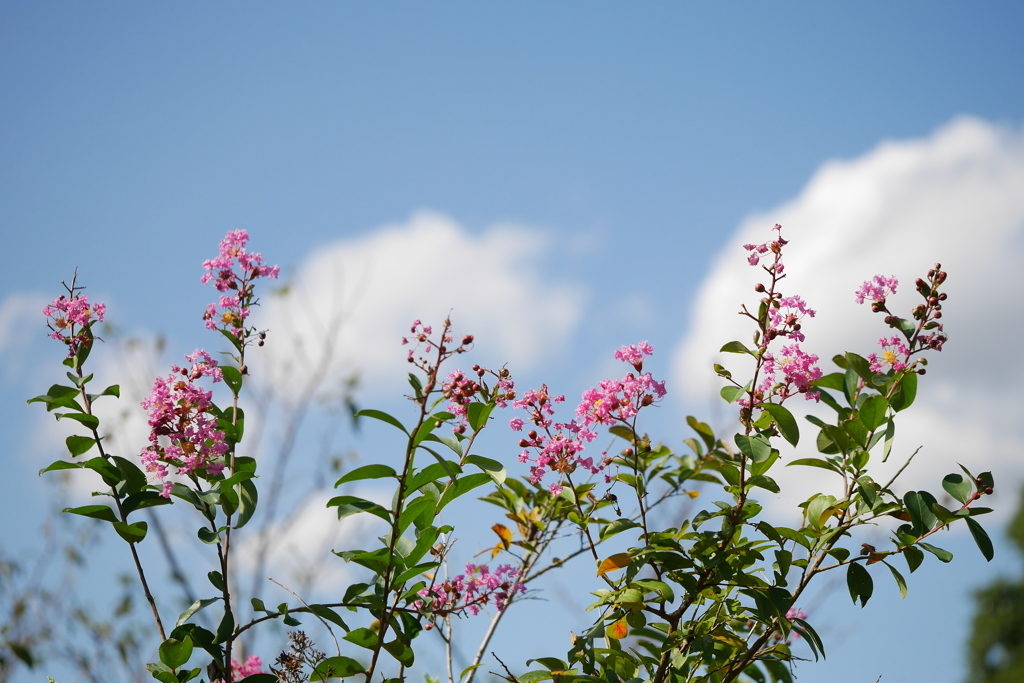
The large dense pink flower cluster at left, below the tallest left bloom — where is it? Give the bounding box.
[141,349,227,498]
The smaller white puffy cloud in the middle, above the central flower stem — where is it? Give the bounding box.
[248,212,584,395]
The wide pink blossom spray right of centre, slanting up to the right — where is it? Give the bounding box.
[509,342,666,496]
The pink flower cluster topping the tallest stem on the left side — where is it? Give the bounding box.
[201,230,281,339]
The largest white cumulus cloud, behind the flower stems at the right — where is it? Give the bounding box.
[674,118,1024,510]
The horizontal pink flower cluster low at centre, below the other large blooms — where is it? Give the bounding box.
[413,564,526,616]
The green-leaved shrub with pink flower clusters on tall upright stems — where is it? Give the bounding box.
[30,225,993,683]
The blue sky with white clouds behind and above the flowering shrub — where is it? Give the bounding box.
[0,2,1024,683]
